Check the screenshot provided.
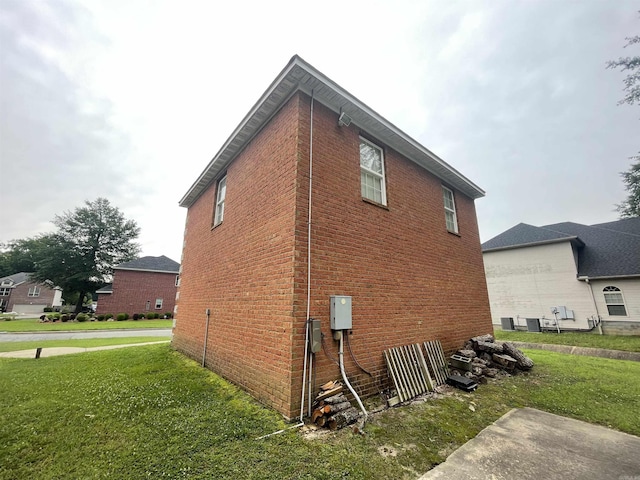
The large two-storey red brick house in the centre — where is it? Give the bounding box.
[173,56,492,417]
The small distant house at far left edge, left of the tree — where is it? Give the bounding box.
[0,272,62,314]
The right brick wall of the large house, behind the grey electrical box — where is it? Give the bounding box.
[293,98,492,408]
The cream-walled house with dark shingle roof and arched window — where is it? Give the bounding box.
[482,217,640,335]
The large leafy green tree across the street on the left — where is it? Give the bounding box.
[32,198,140,313]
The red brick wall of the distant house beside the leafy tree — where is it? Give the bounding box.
[96,270,177,315]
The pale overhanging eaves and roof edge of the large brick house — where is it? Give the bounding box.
[180,55,485,207]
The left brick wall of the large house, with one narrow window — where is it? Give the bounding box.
[173,97,298,414]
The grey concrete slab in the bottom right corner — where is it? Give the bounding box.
[419,408,640,480]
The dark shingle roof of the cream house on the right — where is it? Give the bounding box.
[482,217,640,278]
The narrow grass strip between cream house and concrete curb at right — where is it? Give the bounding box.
[494,330,640,352]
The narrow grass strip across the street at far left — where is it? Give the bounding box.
[0,318,173,332]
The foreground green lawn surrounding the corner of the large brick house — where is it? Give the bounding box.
[0,345,640,479]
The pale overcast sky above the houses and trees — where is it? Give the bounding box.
[0,0,640,261]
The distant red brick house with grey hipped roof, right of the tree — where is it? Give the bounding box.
[96,255,180,315]
